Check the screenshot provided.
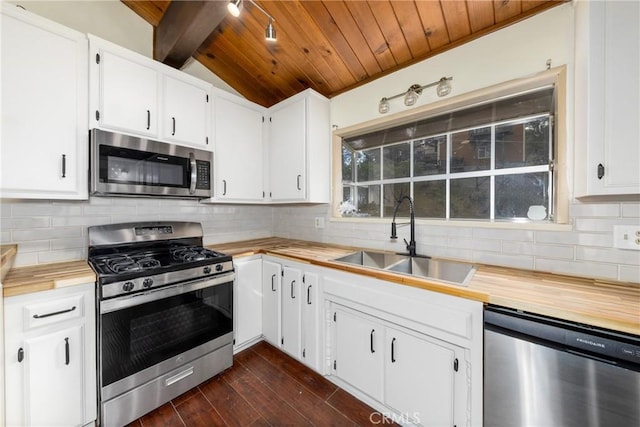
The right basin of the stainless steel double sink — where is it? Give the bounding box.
[387,257,476,286]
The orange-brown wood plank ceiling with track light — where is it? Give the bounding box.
[122,0,565,107]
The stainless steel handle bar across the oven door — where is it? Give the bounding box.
[100,272,236,314]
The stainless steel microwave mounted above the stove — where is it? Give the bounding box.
[90,129,213,199]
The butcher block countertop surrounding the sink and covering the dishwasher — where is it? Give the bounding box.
[211,238,640,335]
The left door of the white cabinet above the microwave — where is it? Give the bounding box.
[94,49,158,137]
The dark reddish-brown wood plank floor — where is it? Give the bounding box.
[130,342,390,427]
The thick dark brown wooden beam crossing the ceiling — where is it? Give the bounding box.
[153,1,228,68]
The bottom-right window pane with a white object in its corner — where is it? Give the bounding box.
[495,172,549,219]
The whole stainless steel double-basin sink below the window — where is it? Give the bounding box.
[333,251,476,286]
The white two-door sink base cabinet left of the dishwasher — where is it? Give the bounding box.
[323,270,483,426]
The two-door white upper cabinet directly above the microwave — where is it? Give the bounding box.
[89,35,212,148]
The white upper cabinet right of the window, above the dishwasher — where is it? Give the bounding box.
[575,0,640,197]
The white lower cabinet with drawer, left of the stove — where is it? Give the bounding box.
[4,283,97,426]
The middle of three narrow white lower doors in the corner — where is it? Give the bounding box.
[280,266,303,359]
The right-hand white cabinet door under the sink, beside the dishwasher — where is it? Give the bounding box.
[384,328,456,426]
